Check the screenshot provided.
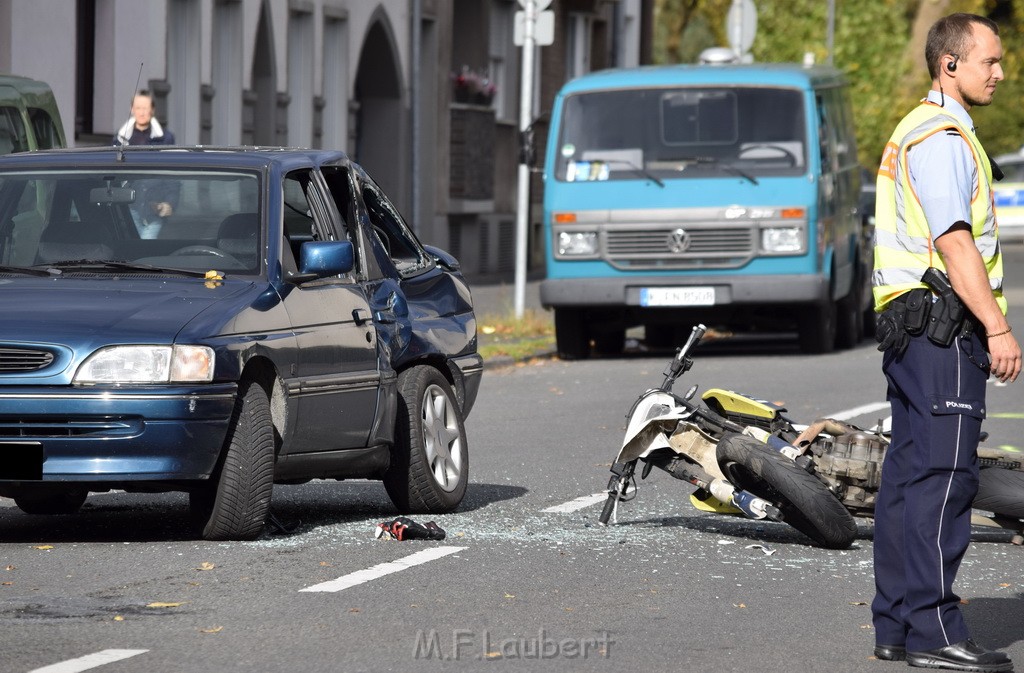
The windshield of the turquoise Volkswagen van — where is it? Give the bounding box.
[555,87,807,182]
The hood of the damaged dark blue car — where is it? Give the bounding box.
[0,277,254,347]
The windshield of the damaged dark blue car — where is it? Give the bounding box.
[0,168,262,275]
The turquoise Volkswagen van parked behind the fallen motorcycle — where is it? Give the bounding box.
[541,64,873,359]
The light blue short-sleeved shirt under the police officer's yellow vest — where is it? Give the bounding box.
[907,91,978,240]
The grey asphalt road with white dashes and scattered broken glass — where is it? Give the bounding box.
[0,248,1024,673]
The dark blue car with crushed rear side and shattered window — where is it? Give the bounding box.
[0,146,482,540]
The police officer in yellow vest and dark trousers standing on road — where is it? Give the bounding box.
[871,13,1021,671]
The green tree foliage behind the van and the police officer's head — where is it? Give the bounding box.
[654,0,1024,167]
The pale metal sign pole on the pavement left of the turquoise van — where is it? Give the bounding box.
[515,0,537,319]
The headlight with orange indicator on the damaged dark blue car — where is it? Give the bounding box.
[75,346,214,383]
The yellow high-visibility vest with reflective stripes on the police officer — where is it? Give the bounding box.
[872,102,1007,314]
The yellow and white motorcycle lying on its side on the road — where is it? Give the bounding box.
[599,325,1024,549]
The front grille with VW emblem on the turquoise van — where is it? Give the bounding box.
[603,226,756,268]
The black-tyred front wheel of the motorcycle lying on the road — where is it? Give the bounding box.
[718,434,857,549]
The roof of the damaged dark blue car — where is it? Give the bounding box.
[0,145,351,171]
